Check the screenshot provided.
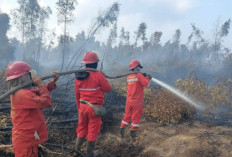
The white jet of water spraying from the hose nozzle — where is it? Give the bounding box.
[151,78,205,110]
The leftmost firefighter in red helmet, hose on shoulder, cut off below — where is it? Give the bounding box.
[6,61,58,157]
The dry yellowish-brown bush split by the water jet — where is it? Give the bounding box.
[144,78,232,124]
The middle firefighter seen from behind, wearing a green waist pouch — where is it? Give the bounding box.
[75,51,110,157]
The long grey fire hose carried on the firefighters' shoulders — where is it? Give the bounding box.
[0,68,134,102]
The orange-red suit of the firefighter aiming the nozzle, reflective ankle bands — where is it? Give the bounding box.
[121,73,150,129]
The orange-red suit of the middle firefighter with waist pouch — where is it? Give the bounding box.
[75,71,110,141]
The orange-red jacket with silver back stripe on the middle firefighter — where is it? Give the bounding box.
[75,71,110,109]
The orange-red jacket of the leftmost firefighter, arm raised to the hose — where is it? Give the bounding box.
[11,82,56,149]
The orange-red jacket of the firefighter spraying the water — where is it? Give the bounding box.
[127,73,150,103]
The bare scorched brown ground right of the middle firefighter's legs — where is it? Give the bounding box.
[94,110,232,157]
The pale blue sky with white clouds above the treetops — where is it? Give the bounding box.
[0,0,232,48]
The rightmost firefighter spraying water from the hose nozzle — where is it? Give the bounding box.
[120,60,151,142]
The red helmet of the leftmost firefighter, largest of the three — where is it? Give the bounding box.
[6,61,32,81]
